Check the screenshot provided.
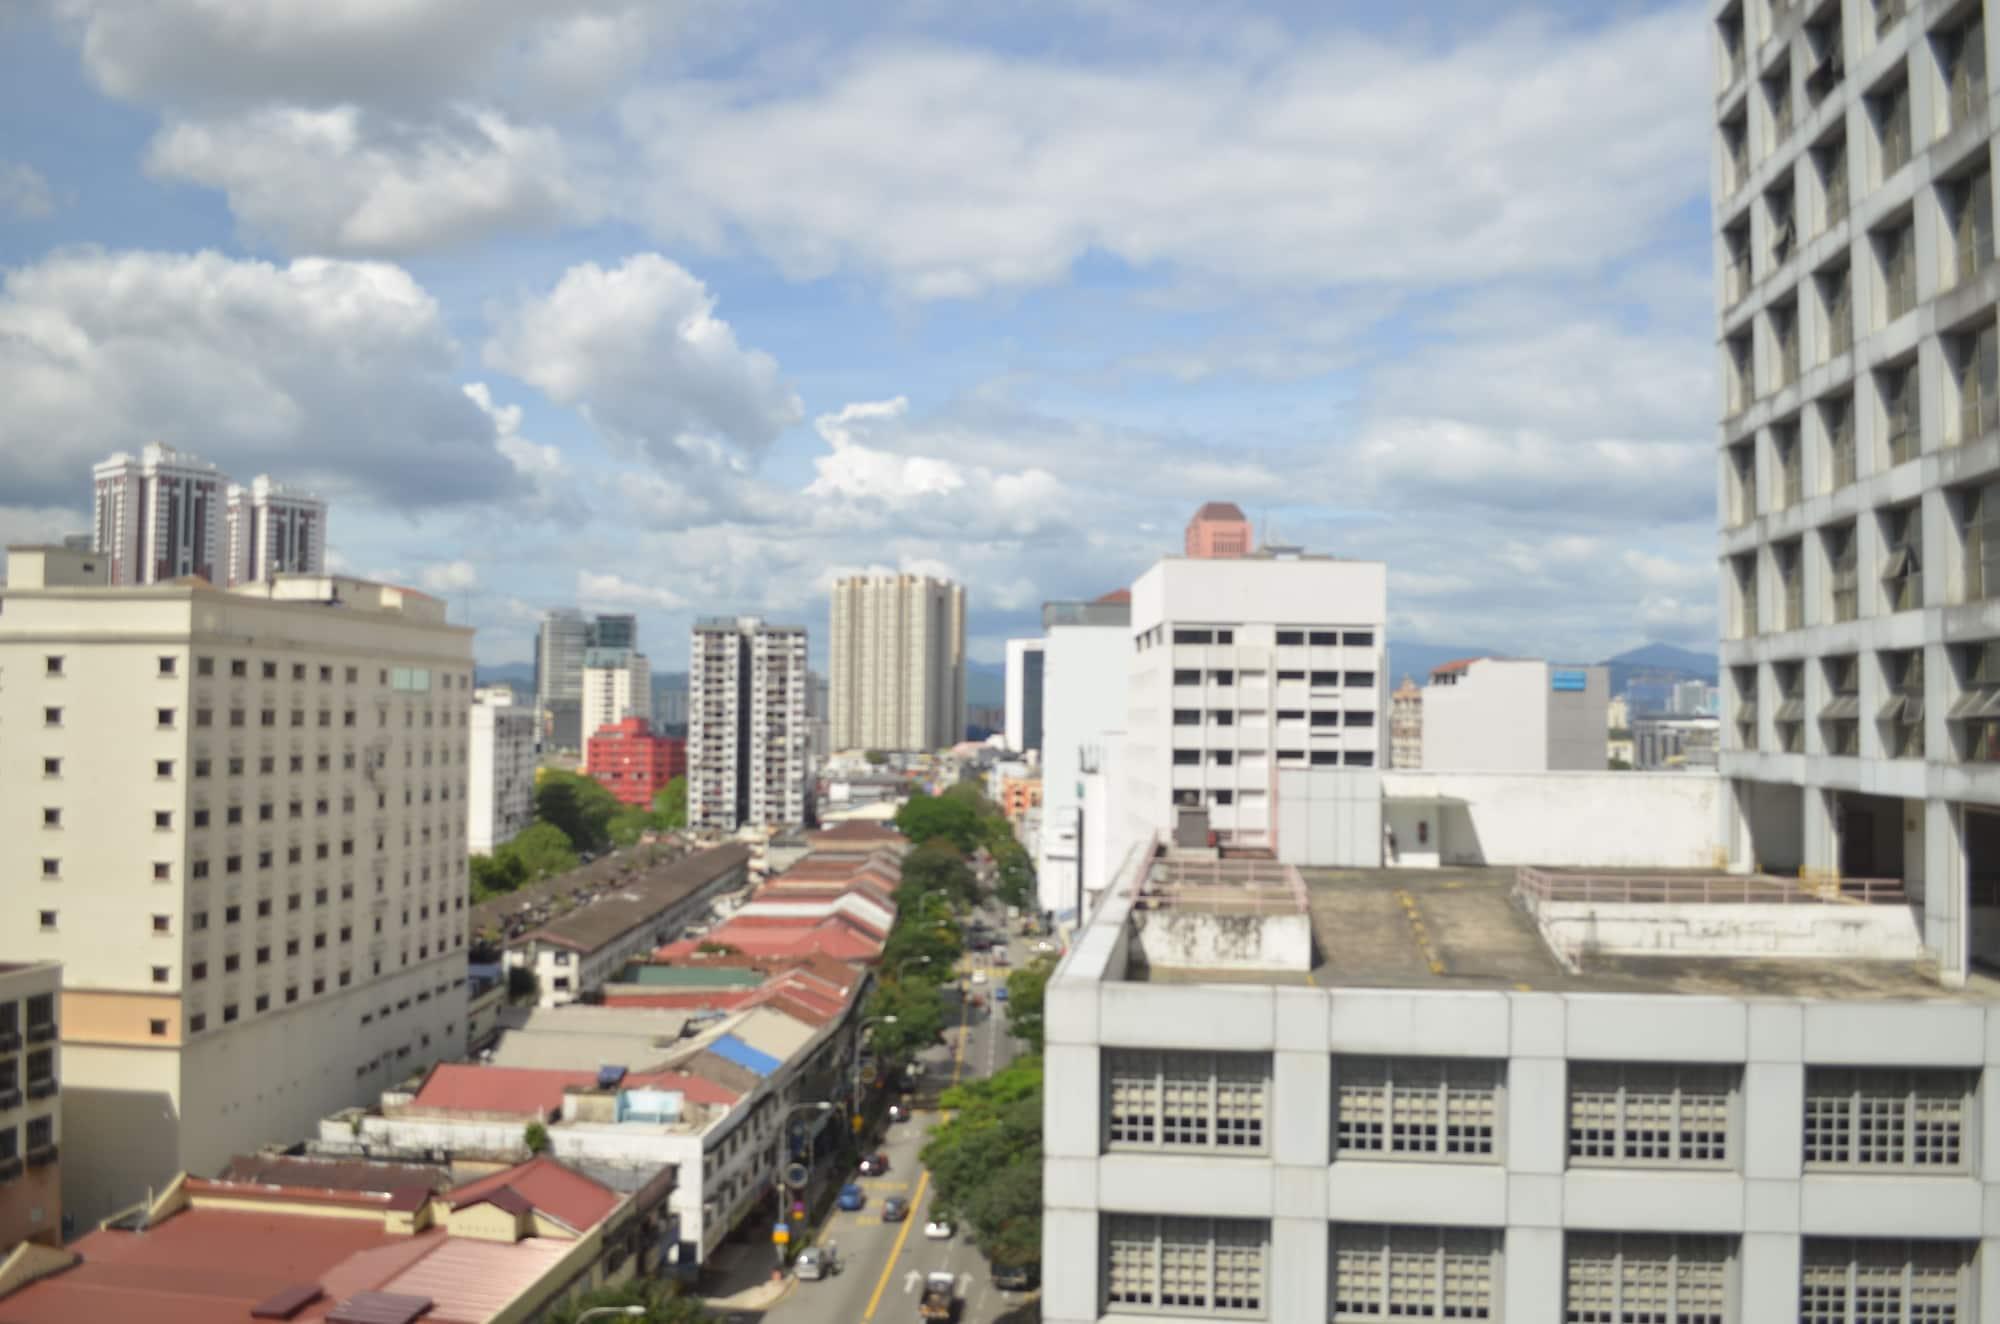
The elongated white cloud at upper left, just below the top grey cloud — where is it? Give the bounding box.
[146,106,598,254]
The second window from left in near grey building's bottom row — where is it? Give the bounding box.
[1330,1224,1500,1322]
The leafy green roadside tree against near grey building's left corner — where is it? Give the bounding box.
[924,1056,1042,1266]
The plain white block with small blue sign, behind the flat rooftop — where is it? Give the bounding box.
[1418,658,1610,772]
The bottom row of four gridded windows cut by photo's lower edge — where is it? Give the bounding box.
[1098,1214,1978,1324]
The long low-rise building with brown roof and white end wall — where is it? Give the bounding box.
[504,842,750,1006]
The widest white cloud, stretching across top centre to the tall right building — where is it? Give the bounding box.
[624,8,1708,298]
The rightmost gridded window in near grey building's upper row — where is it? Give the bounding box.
[1806,1066,1974,1172]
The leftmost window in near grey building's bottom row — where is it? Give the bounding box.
[1104,1214,1270,1316]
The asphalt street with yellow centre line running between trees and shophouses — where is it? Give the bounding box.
[764,920,1028,1324]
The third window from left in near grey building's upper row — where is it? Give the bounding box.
[1570,1062,1736,1164]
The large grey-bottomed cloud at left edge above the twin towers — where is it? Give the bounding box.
[0,250,522,510]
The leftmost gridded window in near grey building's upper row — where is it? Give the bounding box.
[1104,1048,1270,1150]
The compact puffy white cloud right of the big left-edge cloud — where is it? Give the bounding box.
[486,252,804,464]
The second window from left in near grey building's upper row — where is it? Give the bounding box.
[1334,1058,1502,1160]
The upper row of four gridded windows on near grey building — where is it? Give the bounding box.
[1102,1048,1976,1172]
